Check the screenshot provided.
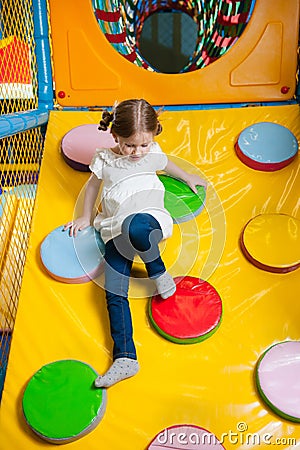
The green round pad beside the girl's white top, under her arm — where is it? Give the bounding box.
[159,175,206,223]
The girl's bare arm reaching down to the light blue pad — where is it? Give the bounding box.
[64,174,102,236]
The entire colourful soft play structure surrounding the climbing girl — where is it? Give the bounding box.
[0,0,300,450]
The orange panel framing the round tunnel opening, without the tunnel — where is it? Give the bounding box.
[50,0,299,106]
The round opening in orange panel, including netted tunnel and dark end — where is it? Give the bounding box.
[92,0,255,73]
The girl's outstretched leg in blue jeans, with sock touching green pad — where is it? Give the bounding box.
[95,236,139,387]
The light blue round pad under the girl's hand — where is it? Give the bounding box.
[40,226,104,283]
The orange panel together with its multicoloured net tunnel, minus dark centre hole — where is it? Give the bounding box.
[50,0,298,106]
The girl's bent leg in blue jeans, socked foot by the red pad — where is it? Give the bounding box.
[122,213,176,298]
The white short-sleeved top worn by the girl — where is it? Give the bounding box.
[90,142,173,243]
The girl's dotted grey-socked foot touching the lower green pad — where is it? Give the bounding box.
[95,358,140,387]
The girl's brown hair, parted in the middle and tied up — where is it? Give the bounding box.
[99,99,162,138]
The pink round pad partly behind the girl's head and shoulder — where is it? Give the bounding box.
[61,124,115,172]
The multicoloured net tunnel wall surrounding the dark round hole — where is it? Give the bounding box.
[92,0,255,72]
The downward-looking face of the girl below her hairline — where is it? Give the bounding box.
[114,132,154,161]
